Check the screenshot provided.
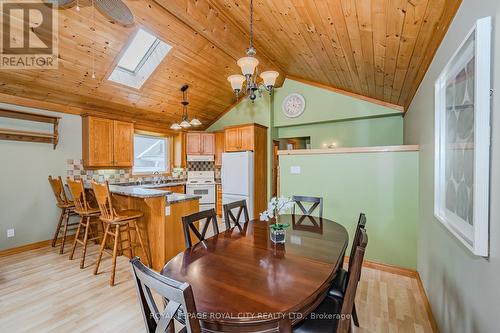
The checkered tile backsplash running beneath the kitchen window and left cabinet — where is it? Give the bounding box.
[66,159,187,184]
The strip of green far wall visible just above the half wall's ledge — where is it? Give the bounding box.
[277,115,403,148]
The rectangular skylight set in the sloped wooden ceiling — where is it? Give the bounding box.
[108,29,172,89]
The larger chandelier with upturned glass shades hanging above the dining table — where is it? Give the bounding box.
[227,0,279,102]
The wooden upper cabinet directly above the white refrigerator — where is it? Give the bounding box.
[224,124,267,152]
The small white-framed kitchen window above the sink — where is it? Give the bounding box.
[132,134,169,173]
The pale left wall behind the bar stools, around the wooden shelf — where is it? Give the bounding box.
[0,103,82,250]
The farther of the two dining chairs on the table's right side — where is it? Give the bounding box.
[328,213,366,327]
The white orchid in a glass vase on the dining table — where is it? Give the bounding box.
[260,197,294,243]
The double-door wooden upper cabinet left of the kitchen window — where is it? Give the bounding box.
[82,116,134,168]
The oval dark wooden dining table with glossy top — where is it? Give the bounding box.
[161,215,348,332]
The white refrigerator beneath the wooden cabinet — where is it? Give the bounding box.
[221,151,254,219]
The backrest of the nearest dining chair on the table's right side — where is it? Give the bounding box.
[337,229,368,333]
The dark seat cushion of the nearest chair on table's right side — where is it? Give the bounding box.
[293,297,342,333]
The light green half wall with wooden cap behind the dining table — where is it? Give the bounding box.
[280,152,418,269]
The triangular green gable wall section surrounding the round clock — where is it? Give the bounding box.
[274,79,401,127]
